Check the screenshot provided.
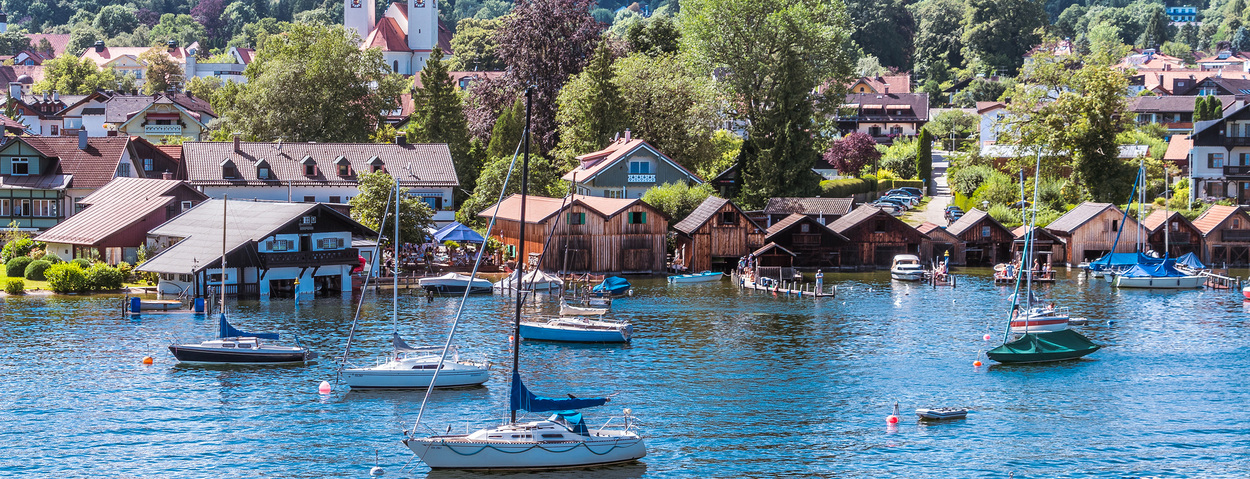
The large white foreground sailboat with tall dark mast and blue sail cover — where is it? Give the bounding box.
[404,88,646,469]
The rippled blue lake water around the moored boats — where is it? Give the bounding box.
[0,270,1250,478]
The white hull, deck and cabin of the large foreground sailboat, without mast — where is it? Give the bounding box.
[404,409,646,470]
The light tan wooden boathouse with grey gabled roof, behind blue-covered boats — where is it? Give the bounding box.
[1046,203,1149,265]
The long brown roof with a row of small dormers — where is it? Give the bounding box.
[183,141,460,188]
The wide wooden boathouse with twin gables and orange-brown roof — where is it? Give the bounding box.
[478,195,669,274]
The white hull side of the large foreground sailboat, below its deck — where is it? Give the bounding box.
[404,435,646,470]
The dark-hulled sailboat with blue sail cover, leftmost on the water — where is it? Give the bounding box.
[169,196,318,364]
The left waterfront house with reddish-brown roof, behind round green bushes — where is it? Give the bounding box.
[35,176,208,265]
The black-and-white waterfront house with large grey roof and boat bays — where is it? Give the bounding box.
[136,199,378,298]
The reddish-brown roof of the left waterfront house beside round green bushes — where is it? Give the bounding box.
[36,178,208,245]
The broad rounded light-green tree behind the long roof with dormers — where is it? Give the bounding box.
[213,24,406,143]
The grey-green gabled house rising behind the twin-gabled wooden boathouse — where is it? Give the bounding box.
[561,130,704,199]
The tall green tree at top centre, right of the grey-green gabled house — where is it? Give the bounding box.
[679,0,851,208]
